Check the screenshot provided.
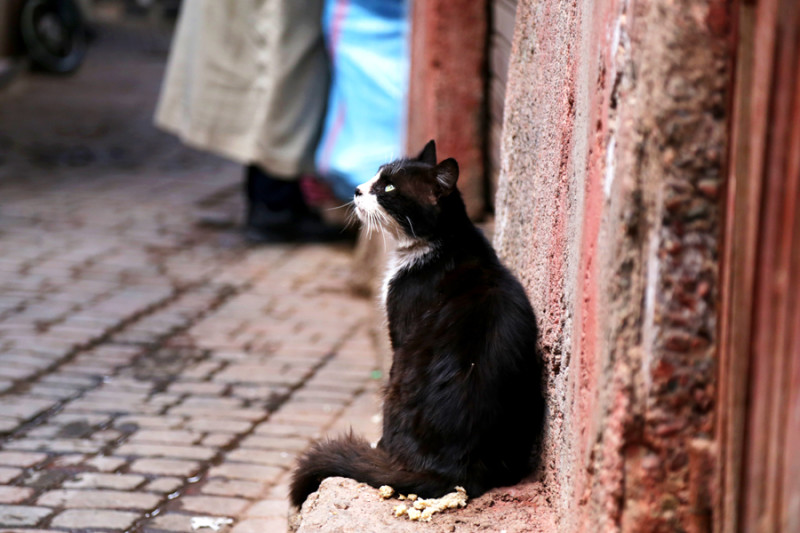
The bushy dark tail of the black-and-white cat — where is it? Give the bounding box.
[290,433,455,507]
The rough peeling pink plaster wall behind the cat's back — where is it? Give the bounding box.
[495,0,731,532]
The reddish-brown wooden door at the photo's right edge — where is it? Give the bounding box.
[714,0,800,533]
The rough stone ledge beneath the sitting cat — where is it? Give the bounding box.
[294,478,557,533]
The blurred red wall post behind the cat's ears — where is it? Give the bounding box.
[408,0,488,218]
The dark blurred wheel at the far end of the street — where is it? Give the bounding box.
[20,0,86,74]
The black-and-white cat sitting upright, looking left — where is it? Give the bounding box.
[291,141,544,506]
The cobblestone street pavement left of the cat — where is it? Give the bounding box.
[0,14,378,533]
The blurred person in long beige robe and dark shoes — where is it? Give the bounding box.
[155,0,342,242]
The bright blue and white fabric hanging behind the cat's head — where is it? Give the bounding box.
[315,0,409,199]
